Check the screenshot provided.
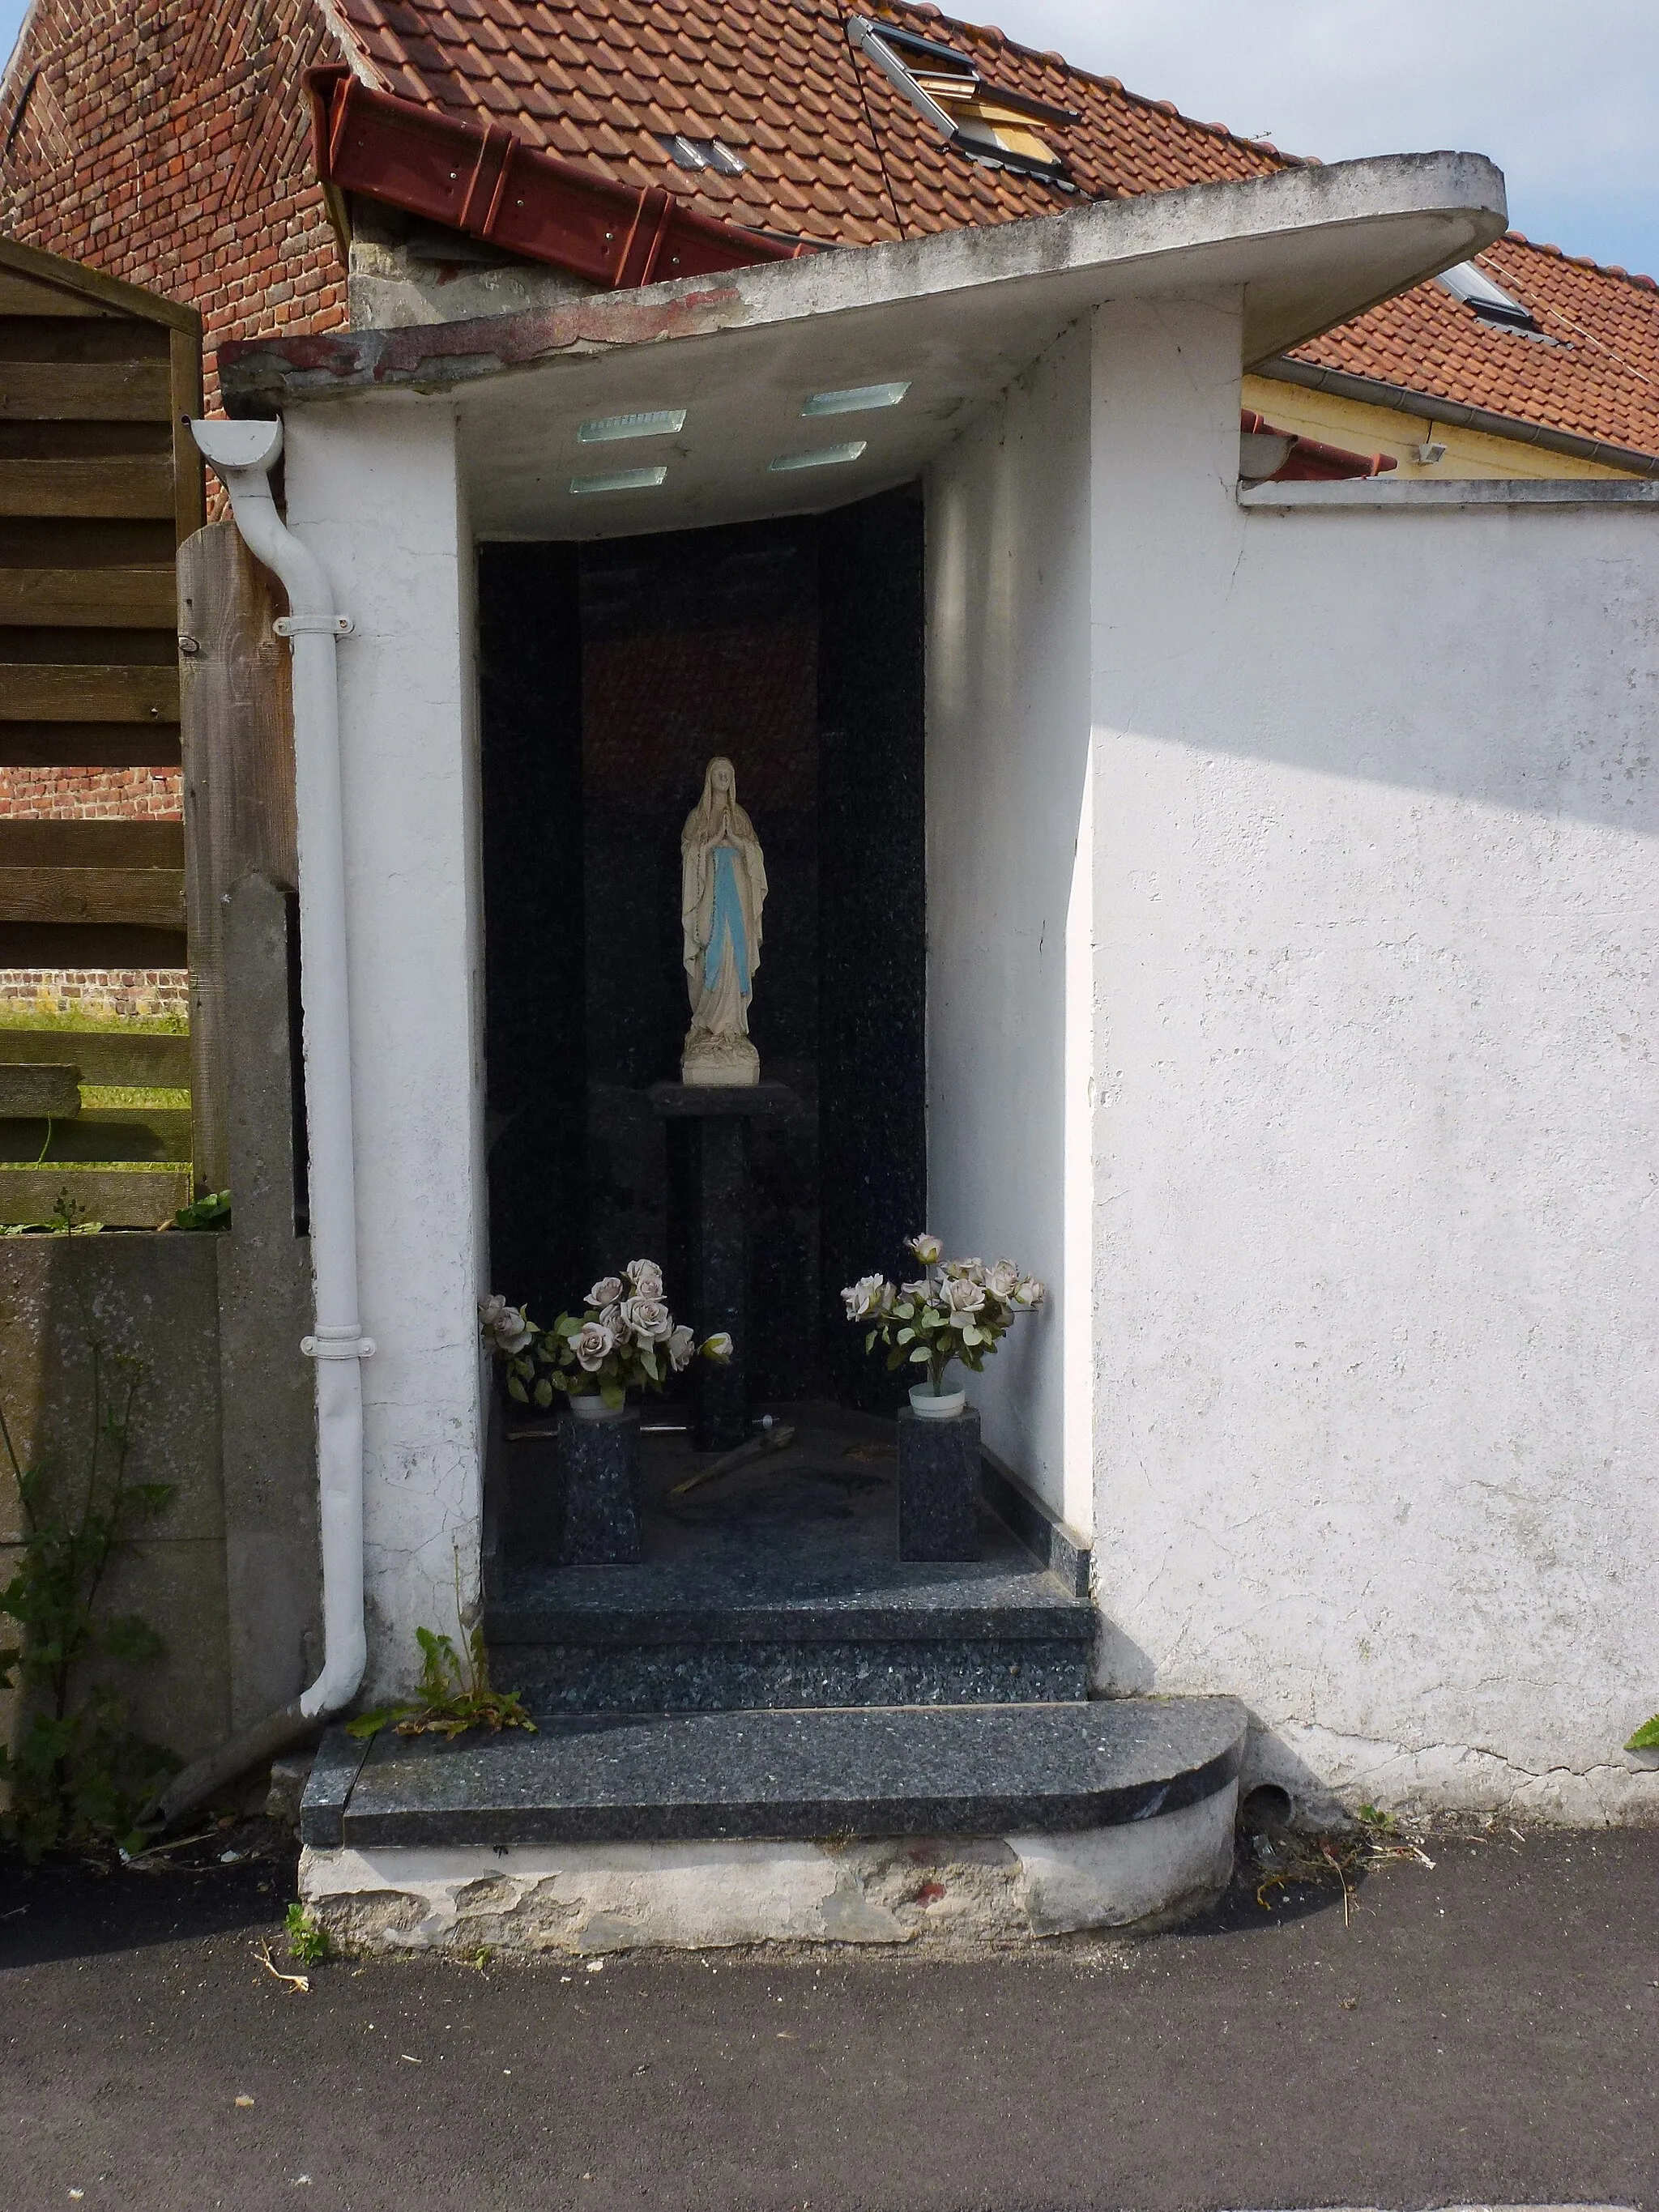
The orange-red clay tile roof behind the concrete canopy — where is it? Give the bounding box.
[334,0,1659,454]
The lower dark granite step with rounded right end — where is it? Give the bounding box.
[301,1697,1247,1852]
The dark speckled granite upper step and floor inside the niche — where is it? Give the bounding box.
[484,1409,1095,1715]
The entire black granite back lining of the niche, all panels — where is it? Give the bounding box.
[480,491,924,1407]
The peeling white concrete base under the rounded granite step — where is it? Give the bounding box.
[299,1783,1239,1958]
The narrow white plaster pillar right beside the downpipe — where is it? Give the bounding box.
[285,399,487,1692]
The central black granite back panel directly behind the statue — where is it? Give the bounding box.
[582,520,818,1400]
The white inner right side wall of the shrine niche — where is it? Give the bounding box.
[927,327,1097,1528]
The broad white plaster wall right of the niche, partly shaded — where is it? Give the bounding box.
[1093,331,1659,1818]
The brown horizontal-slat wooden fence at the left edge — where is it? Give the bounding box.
[0,239,203,1225]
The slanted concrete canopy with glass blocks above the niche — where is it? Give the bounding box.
[221,152,1504,538]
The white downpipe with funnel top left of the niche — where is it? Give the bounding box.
[190,423,373,1719]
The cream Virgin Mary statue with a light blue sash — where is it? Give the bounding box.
[679,757,766,1086]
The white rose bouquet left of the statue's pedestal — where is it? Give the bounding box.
[478,1259,732,1407]
